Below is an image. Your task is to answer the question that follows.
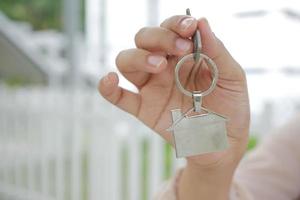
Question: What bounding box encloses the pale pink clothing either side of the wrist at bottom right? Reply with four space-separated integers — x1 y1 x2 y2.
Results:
155 116 300 200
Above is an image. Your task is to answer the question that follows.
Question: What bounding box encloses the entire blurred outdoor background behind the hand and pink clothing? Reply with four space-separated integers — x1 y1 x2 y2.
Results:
0 0 300 200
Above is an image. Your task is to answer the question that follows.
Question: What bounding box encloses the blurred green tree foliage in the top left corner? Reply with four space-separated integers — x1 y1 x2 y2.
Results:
0 0 84 30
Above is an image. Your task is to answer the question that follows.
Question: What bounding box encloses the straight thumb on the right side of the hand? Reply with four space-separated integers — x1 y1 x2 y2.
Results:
198 18 245 80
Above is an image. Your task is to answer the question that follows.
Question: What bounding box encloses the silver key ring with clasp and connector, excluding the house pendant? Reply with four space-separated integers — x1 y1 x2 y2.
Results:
175 9 218 112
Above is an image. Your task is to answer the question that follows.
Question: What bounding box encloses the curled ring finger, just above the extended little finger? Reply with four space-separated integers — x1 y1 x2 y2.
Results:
116 49 167 88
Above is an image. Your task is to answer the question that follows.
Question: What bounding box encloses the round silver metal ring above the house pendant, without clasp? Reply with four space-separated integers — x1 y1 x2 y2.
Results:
175 53 218 97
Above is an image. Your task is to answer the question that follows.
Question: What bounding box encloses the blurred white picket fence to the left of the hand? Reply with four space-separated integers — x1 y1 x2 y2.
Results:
0 87 184 200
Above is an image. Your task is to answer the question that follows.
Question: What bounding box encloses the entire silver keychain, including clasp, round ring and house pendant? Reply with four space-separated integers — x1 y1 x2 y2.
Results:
167 9 228 158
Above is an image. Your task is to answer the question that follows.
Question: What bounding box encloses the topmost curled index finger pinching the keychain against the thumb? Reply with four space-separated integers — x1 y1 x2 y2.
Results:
160 15 197 38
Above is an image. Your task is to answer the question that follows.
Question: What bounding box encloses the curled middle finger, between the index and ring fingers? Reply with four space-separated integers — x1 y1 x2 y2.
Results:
135 27 193 56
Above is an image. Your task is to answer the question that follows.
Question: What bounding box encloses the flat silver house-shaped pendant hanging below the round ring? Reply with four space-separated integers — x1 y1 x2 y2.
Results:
168 109 228 158
